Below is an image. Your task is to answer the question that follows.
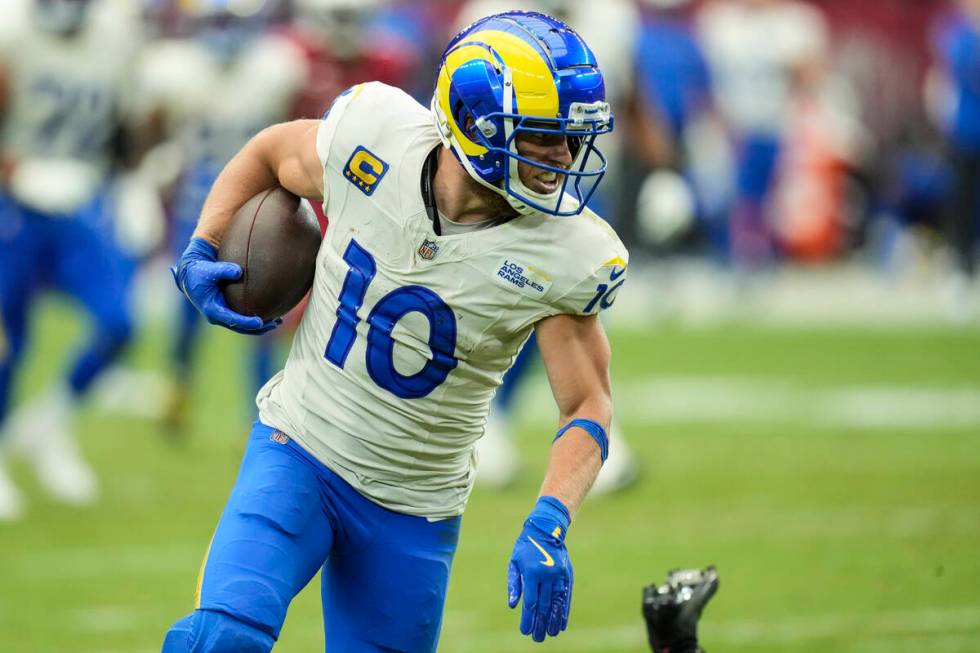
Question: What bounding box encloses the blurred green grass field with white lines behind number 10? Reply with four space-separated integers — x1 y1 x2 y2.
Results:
0 304 980 653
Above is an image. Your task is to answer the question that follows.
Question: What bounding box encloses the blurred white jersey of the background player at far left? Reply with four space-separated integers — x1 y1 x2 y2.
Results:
0 0 141 214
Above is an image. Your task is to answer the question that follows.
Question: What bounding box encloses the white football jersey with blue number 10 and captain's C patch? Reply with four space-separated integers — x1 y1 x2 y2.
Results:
258 82 627 518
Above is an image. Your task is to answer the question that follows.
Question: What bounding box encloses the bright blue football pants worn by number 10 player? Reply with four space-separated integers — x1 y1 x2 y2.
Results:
163 422 460 653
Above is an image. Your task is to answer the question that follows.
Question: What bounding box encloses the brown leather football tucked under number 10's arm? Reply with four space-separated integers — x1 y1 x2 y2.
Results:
218 187 321 320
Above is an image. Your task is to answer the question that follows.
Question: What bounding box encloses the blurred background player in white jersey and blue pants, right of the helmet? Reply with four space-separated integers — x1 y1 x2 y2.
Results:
699 0 827 272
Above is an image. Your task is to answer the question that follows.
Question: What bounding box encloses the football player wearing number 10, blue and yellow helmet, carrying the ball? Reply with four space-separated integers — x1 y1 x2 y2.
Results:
163 12 628 653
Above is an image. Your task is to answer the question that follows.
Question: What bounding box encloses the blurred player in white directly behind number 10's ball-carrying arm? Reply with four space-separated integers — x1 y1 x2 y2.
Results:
143 0 308 429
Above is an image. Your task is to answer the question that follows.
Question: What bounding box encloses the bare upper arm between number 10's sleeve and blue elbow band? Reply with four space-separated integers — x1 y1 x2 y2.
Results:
534 315 610 415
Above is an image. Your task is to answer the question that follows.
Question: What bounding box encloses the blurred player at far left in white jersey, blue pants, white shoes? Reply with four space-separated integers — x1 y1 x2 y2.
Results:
0 0 147 518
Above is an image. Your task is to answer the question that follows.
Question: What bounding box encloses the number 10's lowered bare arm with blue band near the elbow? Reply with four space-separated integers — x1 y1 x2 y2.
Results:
535 315 612 516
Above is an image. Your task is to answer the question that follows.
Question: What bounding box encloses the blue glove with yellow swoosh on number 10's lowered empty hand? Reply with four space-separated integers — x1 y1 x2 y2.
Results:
507 496 574 642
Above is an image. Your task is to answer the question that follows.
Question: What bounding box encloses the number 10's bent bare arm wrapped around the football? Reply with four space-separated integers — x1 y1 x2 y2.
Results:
194 120 323 246
